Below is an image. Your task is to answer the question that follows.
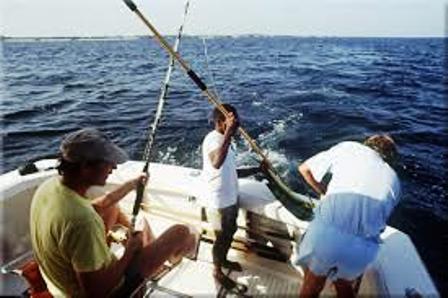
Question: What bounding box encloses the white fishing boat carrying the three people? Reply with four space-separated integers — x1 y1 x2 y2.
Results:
0 159 439 297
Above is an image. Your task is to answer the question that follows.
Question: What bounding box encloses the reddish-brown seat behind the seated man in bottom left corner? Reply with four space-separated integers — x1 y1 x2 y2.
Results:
1 252 53 298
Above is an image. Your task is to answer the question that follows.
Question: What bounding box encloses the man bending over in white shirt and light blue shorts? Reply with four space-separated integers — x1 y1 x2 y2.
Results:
295 135 400 297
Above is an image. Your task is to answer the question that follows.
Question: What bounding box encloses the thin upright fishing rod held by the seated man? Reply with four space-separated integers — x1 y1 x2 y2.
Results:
131 0 190 230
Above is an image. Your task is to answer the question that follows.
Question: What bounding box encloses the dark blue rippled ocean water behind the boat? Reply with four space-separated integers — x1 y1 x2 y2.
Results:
0 36 448 293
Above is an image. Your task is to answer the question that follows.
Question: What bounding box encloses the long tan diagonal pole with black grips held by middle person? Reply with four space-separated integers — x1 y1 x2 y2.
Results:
123 0 314 219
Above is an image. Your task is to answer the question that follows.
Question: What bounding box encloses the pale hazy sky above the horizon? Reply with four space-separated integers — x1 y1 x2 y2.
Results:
0 0 448 37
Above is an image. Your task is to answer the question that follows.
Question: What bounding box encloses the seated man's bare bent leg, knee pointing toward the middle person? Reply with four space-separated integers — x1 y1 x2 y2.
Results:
136 225 196 277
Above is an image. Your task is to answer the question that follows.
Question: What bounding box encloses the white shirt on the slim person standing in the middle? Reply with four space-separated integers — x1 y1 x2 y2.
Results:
202 130 238 209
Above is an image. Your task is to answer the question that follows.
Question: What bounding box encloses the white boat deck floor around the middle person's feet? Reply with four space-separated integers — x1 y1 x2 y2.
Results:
128 193 334 297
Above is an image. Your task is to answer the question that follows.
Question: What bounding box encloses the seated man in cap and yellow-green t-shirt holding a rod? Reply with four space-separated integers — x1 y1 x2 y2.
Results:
30 129 195 297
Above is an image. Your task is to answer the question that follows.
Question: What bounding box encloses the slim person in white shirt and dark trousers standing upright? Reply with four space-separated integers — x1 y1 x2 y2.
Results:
202 104 260 289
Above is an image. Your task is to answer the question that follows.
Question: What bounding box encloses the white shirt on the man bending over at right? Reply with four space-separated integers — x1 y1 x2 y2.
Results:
305 142 400 238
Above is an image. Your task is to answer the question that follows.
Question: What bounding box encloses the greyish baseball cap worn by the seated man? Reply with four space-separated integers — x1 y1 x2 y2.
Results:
59 128 128 164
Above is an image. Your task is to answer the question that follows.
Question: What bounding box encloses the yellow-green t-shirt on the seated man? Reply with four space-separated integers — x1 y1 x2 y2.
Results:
30 177 115 297
